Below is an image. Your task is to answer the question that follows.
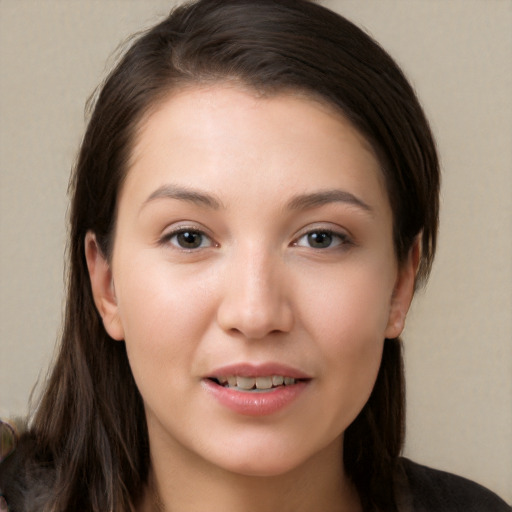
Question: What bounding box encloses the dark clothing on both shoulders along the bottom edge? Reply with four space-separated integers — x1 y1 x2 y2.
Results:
0 436 512 512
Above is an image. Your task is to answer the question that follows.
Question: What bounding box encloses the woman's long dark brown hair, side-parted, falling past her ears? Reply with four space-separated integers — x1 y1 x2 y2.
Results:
25 0 439 512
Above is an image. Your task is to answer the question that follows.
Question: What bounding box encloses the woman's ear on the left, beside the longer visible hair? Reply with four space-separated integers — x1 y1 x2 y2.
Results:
85 231 124 340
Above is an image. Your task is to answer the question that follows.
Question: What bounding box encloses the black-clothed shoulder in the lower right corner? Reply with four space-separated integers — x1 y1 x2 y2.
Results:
401 459 512 512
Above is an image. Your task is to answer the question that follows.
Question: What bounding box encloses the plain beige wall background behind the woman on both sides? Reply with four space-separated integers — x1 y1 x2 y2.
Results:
0 0 512 501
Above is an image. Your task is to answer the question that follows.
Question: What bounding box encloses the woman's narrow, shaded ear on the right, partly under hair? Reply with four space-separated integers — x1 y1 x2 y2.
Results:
385 236 421 339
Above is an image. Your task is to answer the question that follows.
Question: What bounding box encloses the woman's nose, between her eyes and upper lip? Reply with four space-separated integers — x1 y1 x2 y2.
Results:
217 245 293 340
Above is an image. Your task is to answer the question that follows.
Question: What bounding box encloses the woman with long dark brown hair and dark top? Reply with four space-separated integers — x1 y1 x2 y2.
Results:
0 0 507 511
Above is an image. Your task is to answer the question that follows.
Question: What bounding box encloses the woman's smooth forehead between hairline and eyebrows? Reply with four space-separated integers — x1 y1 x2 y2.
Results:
125 84 384 211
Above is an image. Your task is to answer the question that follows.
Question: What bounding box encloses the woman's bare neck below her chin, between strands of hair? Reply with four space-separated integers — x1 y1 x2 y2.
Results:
140 439 362 512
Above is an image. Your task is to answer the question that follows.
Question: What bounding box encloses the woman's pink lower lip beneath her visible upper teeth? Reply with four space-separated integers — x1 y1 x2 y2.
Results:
203 379 309 416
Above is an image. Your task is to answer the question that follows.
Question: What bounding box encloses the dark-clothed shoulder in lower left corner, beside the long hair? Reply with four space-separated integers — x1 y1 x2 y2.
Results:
0 433 55 512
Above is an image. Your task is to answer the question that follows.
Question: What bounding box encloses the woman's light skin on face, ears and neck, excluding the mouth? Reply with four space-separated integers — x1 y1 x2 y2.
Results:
86 84 418 512
